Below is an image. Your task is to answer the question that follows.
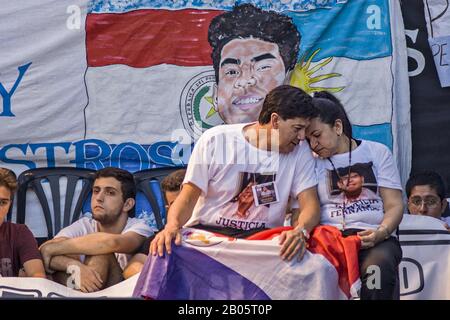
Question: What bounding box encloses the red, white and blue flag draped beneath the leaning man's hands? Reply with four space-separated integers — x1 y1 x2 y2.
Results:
134 226 360 300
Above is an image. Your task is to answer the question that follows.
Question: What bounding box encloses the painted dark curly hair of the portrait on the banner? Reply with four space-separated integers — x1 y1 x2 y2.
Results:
208 3 301 83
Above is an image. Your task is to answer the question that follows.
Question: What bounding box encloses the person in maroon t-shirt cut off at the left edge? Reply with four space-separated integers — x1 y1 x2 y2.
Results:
0 168 45 278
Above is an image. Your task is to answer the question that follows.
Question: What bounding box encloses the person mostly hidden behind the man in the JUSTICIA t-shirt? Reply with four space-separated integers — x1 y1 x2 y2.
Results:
123 169 186 279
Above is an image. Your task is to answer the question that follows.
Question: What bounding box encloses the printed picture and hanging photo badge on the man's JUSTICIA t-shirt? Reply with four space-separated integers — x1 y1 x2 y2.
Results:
220 172 278 227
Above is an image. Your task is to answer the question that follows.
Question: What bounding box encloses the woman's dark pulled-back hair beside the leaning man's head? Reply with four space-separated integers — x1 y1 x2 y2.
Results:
313 91 353 140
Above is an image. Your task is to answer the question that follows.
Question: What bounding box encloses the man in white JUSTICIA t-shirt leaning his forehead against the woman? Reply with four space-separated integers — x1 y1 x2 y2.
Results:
150 85 320 260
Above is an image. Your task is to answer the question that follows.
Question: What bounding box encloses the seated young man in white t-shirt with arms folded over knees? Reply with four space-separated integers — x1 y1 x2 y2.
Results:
41 168 152 292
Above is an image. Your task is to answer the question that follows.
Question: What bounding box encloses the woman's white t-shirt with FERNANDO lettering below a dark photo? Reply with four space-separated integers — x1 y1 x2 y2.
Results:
316 140 402 230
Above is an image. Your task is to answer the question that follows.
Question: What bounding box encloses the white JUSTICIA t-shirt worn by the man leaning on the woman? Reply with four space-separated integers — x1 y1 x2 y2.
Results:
183 124 317 230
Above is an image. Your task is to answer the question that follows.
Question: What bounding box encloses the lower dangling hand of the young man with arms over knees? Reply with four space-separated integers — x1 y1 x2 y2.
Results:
67 263 103 293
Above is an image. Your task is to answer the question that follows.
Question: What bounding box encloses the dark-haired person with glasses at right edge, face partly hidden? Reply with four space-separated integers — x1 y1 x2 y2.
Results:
406 171 450 231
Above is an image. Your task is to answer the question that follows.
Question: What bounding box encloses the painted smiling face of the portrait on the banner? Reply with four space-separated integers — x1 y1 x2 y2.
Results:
216 38 286 124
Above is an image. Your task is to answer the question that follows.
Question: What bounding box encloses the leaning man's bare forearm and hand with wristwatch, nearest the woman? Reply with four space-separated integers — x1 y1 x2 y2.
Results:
280 187 320 261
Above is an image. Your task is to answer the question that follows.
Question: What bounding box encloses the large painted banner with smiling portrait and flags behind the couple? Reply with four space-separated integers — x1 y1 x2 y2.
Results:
0 0 411 185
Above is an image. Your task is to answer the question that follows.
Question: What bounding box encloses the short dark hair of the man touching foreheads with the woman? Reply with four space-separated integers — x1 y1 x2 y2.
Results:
258 85 317 124
